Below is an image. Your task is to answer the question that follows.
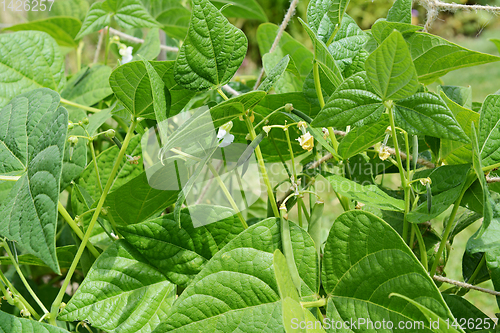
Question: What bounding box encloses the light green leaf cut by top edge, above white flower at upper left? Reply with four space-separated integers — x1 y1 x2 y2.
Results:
76 0 158 39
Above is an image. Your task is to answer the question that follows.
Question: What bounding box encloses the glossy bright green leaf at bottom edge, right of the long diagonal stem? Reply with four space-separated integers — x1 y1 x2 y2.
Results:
58 240 176 333
